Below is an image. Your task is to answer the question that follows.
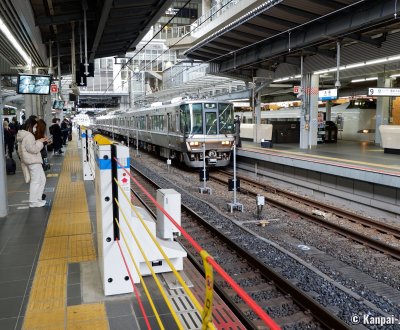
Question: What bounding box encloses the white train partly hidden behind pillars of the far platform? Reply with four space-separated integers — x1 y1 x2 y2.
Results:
235 99 376 143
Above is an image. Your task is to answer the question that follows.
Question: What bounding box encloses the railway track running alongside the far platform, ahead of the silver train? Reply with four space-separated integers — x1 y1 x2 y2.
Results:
210 170 400 260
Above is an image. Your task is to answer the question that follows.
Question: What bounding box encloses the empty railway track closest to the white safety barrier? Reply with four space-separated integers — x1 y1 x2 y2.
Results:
132 168 348 329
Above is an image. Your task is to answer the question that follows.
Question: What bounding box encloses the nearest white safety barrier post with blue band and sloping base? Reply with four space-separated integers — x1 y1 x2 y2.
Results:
94 138 186 295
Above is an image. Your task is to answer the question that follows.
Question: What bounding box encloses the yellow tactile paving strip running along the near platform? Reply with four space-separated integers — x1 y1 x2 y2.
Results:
23 141 109 330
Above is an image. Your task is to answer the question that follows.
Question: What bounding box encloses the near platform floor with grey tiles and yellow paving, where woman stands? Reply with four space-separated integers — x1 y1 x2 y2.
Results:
0 140 244 330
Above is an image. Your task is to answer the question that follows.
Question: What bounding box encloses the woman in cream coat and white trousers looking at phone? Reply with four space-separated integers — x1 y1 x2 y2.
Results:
17 119 47 207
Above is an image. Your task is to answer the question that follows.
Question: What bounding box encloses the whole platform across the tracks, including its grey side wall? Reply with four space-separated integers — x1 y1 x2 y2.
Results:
237 140 400 216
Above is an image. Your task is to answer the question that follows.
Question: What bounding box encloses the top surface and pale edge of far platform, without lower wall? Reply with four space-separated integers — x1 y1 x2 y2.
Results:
237 140 400 189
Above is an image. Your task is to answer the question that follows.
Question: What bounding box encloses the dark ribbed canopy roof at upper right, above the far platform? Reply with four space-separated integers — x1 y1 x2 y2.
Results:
186 0 400 73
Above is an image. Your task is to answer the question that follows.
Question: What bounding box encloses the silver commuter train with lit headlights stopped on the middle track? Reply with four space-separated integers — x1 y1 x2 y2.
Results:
94 100 235 168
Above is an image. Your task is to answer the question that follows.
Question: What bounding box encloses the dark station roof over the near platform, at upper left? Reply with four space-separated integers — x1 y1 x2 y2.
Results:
0 0 172 73
